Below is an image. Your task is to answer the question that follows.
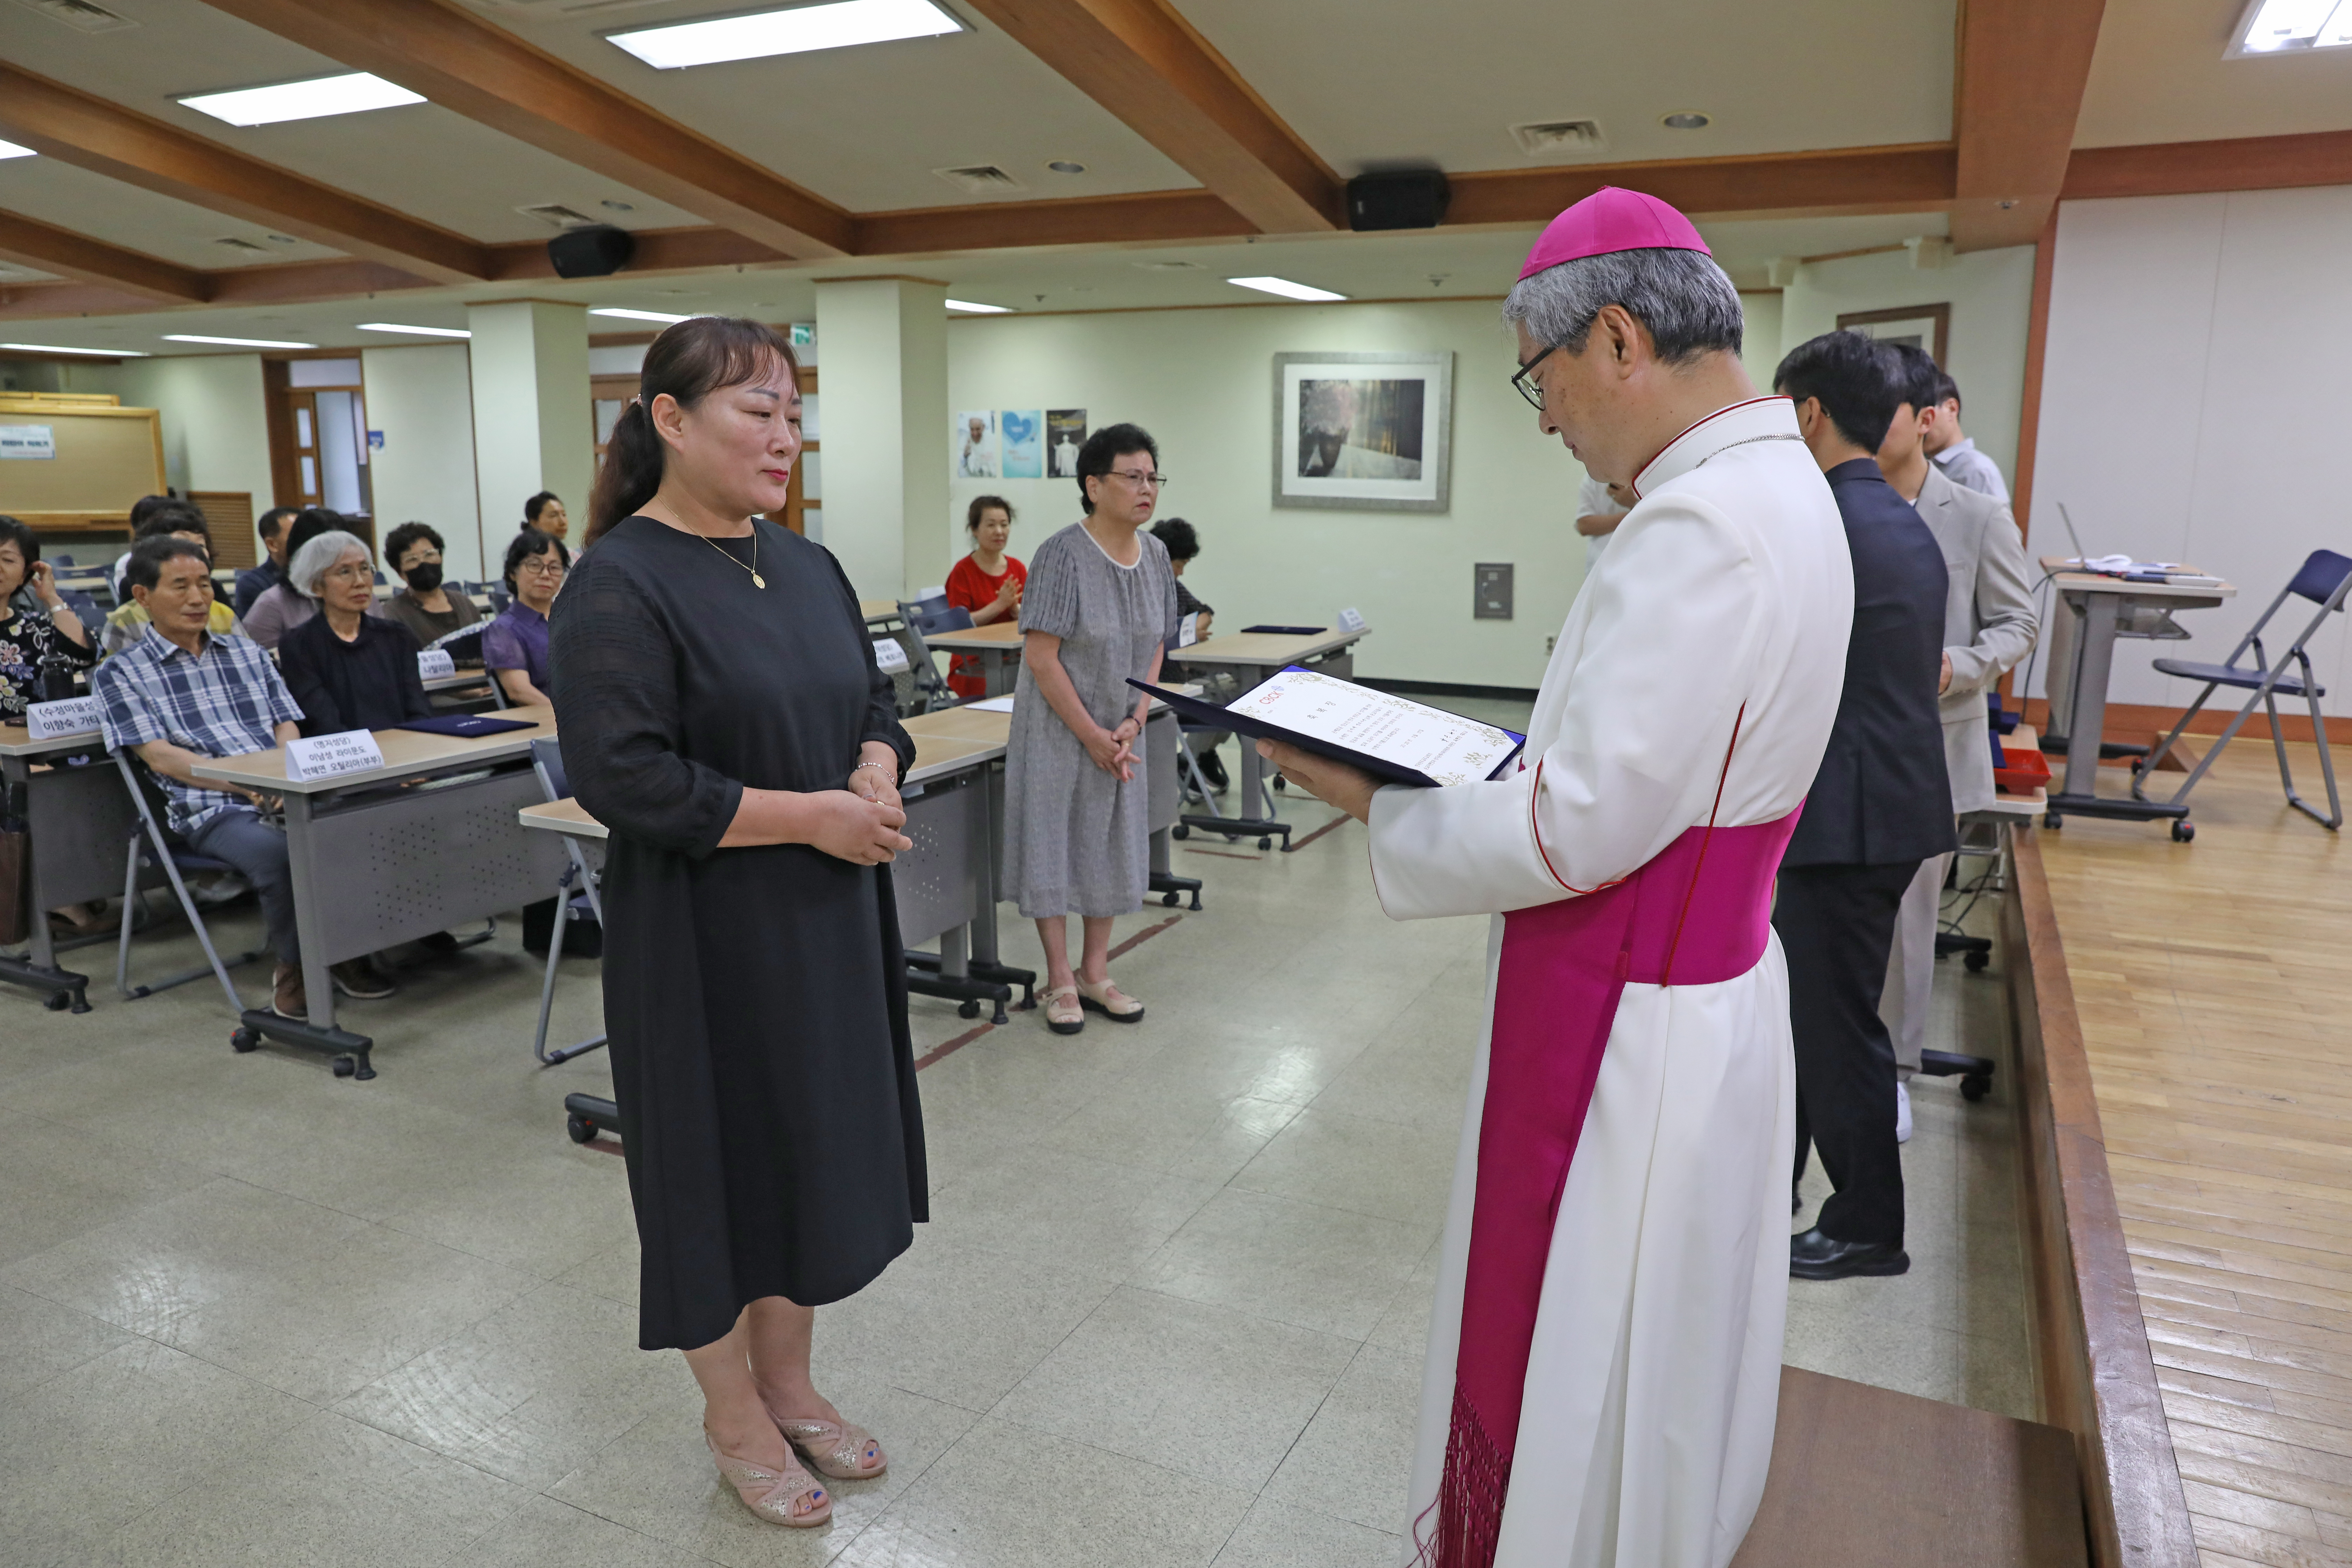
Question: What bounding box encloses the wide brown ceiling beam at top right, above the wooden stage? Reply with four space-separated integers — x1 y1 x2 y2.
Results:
1952 0 2105 252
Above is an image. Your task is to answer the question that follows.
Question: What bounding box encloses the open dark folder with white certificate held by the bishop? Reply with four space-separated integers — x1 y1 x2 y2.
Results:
1127 665 1526 788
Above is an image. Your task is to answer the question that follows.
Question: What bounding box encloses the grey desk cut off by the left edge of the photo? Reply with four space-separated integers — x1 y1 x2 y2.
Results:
0 724 139 1013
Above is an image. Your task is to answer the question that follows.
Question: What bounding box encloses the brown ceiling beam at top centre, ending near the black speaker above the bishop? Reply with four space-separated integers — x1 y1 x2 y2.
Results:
945 0 1348 233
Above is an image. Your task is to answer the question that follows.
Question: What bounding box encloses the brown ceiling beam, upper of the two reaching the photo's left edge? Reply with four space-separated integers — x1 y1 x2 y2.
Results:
0 61 489 282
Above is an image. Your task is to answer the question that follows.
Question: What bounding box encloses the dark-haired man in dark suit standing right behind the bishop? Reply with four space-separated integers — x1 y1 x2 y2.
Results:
1773 331 1954 1279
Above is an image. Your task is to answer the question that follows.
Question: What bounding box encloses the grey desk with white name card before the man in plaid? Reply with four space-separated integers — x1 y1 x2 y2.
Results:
193 708 565 1079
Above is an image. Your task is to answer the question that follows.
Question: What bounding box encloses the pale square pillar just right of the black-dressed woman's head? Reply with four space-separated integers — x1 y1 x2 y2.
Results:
816 278 950 600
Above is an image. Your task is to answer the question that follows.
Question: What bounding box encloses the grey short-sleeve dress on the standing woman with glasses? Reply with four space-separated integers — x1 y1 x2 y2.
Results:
1004 524 1176 919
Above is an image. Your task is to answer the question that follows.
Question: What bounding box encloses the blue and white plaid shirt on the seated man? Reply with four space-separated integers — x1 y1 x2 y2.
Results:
89 625 301 834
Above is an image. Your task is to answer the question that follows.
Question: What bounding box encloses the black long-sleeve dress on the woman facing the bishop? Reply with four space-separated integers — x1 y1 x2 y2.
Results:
550 517 929 1349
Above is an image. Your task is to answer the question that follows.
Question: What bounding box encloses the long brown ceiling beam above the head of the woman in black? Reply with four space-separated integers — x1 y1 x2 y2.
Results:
209 0 854 261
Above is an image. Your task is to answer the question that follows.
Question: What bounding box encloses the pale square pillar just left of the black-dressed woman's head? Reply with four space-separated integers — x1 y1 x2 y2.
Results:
466 299 595 576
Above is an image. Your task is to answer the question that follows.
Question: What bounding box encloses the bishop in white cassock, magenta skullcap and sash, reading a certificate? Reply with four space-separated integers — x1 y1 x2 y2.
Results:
1261 190 1853 1568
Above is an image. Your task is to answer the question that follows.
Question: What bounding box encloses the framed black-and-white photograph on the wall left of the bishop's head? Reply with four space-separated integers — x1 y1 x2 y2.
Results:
1275 350 1454 512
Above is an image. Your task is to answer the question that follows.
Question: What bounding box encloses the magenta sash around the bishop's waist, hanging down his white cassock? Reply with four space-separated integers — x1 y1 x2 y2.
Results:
1416 799 1804 1568
